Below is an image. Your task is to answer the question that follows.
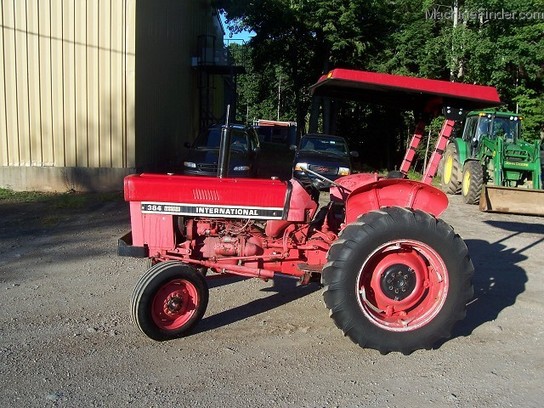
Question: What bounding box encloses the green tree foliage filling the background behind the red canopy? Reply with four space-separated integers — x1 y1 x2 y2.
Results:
218 0 544 168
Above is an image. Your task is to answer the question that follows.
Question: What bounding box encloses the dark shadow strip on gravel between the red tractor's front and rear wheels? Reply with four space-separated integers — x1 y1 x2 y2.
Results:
192 278 321 334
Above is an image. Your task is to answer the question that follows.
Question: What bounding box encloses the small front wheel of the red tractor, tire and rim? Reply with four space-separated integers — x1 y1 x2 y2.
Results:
131 261 209 341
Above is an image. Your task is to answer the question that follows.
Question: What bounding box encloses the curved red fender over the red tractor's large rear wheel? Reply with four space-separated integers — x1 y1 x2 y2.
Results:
346 179 448 224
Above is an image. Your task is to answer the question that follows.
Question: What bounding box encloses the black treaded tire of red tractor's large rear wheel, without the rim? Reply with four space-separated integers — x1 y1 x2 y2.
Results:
324 208 471 353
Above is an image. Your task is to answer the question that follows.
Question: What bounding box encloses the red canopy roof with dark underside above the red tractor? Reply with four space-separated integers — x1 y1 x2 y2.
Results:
310 68 501 113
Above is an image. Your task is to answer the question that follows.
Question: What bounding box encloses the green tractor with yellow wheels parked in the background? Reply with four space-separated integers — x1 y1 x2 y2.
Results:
441 110 542 213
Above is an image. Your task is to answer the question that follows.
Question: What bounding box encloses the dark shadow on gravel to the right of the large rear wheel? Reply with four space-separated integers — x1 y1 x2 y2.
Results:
452 221 544 337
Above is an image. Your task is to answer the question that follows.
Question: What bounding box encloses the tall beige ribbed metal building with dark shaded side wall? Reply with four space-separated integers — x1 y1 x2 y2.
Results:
0 0 239 191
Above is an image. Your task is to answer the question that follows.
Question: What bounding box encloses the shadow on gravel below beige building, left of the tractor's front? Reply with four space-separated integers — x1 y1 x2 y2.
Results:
0 193 130 282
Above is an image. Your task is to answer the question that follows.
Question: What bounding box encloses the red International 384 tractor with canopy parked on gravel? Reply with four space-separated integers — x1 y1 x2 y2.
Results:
119 70 498 354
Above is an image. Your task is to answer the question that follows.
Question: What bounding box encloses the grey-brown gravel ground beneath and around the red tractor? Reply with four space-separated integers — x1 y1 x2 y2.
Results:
0 192 544 407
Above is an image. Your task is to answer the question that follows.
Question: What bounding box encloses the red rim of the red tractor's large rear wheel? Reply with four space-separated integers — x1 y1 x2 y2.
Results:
357 240 449 332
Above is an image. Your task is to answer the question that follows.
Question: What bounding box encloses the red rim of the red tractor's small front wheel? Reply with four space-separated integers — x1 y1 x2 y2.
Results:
151 279 199 330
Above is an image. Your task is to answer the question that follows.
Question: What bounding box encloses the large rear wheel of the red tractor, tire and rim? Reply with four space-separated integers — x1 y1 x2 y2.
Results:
321 207 474 354
